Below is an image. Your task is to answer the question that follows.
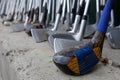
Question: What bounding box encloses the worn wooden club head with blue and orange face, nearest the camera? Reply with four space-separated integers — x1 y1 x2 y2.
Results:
53 46 99 75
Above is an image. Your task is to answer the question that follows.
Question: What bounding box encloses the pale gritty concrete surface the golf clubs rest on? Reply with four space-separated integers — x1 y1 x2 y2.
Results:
0 24 120 80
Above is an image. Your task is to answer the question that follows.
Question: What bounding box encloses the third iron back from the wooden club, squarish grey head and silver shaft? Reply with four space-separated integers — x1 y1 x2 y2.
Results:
31 0 63 43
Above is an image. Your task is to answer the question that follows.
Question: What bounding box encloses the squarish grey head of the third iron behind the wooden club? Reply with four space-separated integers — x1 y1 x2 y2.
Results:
31 29 48 43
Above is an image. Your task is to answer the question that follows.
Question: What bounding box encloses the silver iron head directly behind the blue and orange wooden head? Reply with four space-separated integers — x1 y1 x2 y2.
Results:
54 38 85 53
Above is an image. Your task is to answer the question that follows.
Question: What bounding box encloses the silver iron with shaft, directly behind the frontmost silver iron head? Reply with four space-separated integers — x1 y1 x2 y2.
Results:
48 0 84 47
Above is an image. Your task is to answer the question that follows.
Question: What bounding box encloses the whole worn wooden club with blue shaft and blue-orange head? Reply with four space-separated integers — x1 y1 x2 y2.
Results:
53 0 114 75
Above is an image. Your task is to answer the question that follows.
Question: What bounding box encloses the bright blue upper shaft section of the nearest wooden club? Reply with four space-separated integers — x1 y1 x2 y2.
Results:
97 0 114 33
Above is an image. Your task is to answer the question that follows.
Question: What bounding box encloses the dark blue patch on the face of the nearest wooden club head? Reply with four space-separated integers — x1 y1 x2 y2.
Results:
75 46 99 74
